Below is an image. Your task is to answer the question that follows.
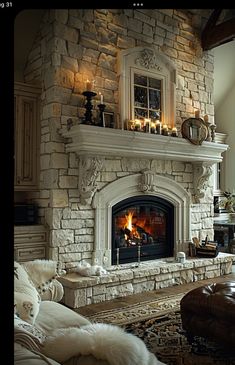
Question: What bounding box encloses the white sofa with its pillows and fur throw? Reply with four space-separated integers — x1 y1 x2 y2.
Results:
14 260 164 365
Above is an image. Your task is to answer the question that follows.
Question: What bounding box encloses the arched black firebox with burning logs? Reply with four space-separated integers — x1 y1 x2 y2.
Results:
112 195 174 265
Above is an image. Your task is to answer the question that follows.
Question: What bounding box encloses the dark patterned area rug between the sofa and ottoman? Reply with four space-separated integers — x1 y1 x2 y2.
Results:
89 294 235 365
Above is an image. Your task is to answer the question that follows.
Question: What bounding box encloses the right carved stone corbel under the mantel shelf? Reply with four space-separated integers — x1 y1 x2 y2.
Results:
193 162 213 203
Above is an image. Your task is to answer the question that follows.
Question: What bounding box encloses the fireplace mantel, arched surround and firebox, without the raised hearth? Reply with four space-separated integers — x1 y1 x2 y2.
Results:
61 124 227 267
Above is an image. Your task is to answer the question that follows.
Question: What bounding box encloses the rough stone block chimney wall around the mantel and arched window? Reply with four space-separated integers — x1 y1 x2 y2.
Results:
25 9 214 266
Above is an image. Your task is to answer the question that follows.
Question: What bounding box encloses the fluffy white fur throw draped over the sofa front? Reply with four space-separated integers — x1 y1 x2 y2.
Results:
42 323 164 365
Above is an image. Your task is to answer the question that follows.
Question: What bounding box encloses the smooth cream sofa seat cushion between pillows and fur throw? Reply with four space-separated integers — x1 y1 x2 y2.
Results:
35 300 90 334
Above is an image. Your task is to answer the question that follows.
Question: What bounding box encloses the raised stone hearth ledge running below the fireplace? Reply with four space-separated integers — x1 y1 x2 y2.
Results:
59 253 235 308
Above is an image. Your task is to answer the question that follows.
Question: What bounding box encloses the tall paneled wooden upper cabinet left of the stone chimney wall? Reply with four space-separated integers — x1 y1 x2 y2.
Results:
14 82 41 191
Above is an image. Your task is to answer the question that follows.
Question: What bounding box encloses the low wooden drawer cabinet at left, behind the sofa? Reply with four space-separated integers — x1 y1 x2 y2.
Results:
14 225 48 262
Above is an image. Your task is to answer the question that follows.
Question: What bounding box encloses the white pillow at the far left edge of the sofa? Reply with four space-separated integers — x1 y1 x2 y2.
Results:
14 261 41 324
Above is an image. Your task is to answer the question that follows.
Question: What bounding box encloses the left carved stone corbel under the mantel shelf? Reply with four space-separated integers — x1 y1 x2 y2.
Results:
78 156 103 205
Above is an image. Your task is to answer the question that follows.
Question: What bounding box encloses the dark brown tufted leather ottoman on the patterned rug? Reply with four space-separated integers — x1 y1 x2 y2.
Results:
180 281 235 349
